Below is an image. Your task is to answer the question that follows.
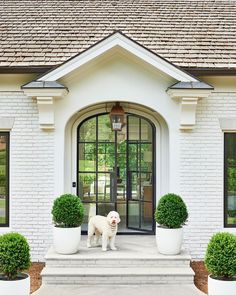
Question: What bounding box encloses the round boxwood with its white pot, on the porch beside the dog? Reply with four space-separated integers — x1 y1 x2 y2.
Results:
52 194 84 254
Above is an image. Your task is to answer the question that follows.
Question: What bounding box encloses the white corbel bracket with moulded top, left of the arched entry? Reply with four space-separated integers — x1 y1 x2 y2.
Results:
23 88 68 130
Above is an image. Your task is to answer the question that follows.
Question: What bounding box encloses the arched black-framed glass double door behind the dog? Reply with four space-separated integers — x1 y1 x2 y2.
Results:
77 114 155 233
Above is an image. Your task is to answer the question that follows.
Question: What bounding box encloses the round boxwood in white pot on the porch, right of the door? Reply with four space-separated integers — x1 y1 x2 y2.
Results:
155 194 188 255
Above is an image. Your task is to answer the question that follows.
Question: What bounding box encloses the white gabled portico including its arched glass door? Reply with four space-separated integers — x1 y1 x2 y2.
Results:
22 32 212 238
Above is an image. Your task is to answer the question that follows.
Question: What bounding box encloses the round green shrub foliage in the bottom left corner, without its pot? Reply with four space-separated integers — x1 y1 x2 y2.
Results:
0 233 31 280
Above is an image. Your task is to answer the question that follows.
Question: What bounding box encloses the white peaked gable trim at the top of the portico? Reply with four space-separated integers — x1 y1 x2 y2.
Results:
37 31 198 82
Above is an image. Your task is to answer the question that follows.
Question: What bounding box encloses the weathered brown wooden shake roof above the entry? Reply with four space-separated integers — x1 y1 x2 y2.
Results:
0 0 236 70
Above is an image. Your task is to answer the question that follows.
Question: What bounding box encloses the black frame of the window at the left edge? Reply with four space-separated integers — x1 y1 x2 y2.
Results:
0 131 10 228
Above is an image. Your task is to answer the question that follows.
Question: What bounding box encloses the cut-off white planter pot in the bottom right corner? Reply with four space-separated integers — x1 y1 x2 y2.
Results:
208 276 236 295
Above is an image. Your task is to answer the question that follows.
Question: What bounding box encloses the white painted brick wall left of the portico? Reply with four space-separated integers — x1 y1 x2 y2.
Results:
0 91 54 261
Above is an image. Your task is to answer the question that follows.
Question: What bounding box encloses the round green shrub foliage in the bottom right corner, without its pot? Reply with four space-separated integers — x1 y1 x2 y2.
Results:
205 233 236 278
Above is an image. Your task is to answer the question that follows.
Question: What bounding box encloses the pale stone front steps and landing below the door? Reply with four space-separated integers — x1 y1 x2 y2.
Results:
41 235 194 286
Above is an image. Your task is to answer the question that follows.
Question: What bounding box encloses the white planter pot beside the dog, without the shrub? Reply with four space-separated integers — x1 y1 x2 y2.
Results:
53 227 81 254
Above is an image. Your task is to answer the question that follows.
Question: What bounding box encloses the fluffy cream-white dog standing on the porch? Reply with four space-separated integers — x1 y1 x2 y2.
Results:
87 211 120 251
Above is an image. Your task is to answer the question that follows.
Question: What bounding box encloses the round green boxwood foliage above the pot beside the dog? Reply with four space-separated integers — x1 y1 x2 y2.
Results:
52 194 84 227
